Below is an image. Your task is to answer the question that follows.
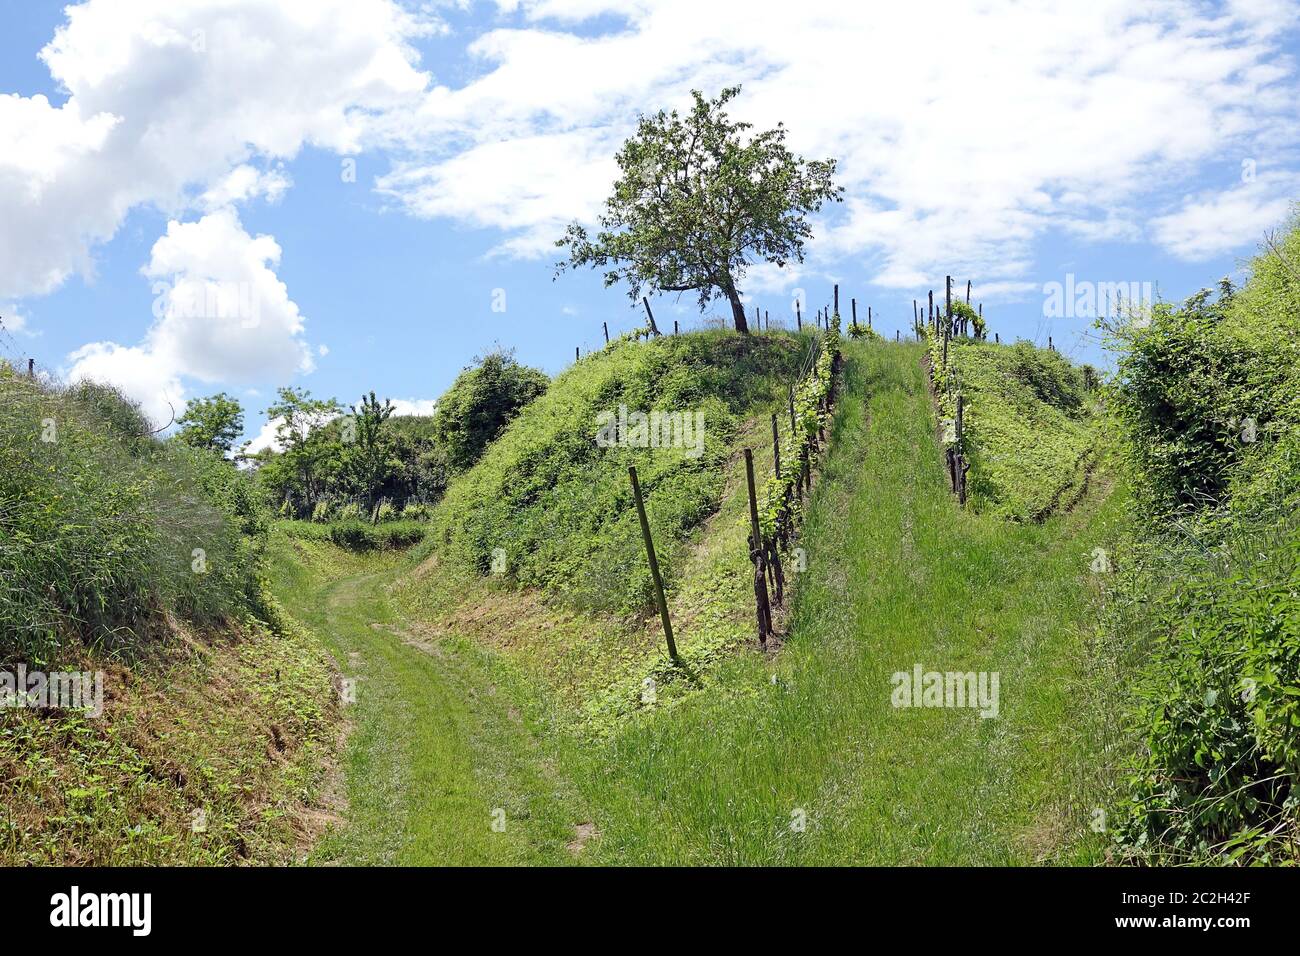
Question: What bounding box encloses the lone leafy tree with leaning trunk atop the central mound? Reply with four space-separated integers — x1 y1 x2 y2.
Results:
555 86 844 332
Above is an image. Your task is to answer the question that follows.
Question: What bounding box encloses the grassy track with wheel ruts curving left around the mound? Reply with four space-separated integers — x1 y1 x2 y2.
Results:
272 531 586 865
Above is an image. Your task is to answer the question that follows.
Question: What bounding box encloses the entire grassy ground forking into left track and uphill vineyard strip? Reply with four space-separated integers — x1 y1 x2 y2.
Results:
276 343 1117 864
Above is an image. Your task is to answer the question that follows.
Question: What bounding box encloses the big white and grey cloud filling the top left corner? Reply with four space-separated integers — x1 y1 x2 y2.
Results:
0 0 433 297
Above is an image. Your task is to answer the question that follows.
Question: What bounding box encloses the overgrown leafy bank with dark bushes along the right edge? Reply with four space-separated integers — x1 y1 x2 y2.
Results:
1108 210 1300 864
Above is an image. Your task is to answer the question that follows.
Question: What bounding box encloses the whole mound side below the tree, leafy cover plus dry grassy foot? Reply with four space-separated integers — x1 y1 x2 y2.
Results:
395 330 814 721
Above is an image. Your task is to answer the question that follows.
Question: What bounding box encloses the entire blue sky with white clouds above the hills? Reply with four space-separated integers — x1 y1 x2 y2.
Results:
0 0 1300 450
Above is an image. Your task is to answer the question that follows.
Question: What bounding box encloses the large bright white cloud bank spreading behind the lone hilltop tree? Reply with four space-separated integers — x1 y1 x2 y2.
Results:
380 0 1300 289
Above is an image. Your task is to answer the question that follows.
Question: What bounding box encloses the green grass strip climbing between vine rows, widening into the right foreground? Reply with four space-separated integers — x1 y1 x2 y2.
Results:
559 345 1114 864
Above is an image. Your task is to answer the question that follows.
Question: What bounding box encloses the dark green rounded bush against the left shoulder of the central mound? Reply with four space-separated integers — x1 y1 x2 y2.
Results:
433 350 550 470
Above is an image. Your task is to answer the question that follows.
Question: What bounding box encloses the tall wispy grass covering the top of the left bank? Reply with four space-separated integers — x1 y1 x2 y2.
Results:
0 365 264 662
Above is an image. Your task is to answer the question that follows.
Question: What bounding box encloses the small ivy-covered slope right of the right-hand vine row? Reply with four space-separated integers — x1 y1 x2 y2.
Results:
930 334 1097 522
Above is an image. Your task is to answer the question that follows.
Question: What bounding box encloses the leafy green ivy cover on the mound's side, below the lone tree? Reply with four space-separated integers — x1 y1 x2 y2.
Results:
429 332 810 613
